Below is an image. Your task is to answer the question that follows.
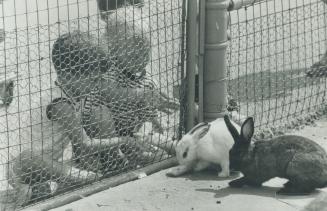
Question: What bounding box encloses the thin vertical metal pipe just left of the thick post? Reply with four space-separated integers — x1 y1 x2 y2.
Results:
185 0 198 131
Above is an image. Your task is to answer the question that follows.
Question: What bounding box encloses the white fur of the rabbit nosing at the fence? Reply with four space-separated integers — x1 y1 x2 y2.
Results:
167 118 240 177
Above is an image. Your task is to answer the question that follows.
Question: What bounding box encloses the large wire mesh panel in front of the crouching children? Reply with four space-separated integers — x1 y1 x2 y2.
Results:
0 0 183 210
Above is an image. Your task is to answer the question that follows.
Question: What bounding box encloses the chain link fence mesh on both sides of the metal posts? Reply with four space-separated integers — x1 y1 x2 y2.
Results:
0 0 327 210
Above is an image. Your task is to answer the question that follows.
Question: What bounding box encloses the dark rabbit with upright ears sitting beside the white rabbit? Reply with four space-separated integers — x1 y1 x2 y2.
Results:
224 115 327 195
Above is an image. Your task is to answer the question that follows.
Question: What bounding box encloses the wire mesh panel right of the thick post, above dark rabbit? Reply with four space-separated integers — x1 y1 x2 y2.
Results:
227 0 327 132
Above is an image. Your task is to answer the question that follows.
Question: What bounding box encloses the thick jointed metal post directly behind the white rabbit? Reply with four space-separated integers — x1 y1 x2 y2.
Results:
203 0 230 121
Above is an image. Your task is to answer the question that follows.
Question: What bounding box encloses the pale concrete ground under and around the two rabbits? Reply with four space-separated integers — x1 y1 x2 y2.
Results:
32 118 327 211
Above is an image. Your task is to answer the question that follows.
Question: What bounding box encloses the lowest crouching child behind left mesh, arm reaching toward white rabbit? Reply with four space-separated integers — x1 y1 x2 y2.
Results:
8 91 176 206
